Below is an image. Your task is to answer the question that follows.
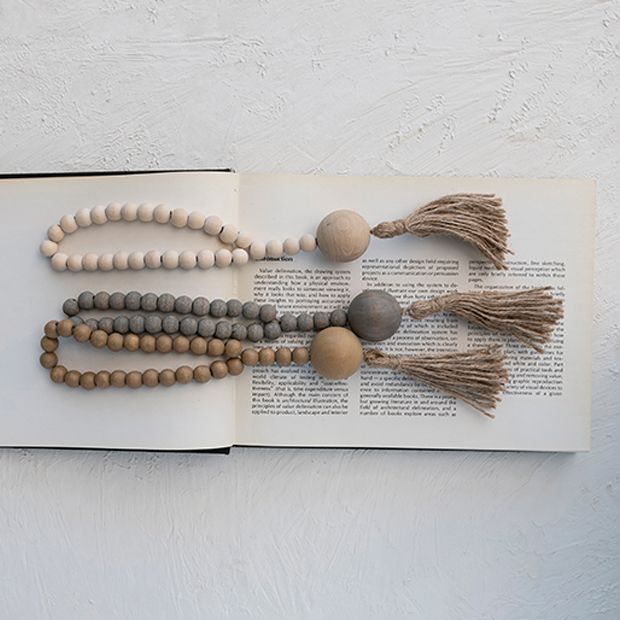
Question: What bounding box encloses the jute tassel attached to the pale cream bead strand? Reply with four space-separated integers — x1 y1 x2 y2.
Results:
370 194 510 269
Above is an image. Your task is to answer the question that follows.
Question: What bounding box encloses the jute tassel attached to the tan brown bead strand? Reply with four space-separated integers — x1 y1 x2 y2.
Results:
364 345 508 418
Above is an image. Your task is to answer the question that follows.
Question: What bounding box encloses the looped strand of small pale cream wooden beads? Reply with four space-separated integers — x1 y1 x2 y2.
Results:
39 202 317 272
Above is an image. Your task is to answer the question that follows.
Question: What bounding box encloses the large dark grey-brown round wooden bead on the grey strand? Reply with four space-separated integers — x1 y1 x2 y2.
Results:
349 291 402 342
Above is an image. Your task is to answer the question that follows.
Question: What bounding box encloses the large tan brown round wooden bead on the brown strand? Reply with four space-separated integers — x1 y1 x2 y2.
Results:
310 327 364 379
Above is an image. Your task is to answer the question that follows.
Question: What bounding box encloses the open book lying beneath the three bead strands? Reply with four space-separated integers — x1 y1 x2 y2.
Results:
0 172 595 451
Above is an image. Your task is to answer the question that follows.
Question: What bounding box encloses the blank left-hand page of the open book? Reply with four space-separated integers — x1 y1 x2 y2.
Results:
0 172 238 450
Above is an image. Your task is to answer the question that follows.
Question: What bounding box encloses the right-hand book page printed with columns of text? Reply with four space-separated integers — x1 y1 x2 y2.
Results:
236 175 595 451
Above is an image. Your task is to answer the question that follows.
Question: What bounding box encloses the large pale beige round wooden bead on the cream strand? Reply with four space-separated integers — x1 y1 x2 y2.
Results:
316 209 370 263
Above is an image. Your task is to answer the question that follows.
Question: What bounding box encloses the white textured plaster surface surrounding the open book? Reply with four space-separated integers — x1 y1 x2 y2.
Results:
0 0 620 620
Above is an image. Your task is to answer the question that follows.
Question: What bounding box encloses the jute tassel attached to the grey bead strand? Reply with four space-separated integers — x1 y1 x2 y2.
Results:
404 286 564 353
